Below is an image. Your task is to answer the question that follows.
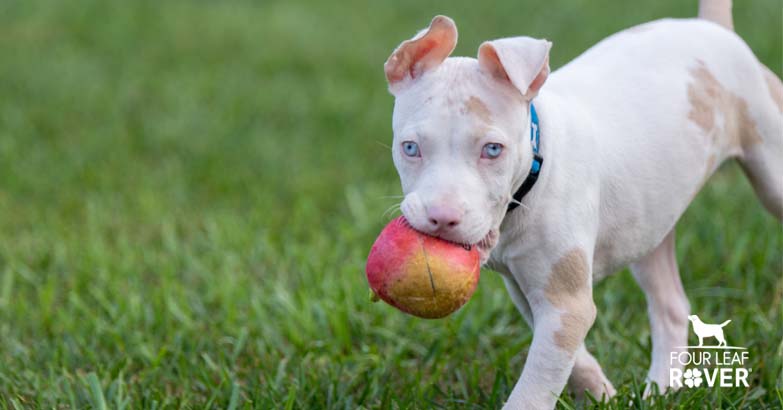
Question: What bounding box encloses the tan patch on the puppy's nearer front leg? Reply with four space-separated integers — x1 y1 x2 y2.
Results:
545 249 595 353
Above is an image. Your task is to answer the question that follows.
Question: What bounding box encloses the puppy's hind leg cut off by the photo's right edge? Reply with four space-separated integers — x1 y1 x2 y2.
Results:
738 64 783 220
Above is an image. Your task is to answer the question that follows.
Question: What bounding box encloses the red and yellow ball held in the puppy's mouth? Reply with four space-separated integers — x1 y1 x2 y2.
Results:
366 216 481 319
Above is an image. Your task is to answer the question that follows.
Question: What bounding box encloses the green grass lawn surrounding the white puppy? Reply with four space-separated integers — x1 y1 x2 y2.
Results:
0 0 783 409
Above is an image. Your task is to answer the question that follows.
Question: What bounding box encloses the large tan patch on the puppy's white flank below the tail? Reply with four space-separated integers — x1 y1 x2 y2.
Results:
688 60 761 150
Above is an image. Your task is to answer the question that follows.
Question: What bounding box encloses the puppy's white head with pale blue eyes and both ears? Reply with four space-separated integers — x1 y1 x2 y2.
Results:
384 16 551 262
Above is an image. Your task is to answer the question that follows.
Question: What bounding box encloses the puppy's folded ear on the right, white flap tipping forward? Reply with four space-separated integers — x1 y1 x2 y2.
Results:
478 37 552 100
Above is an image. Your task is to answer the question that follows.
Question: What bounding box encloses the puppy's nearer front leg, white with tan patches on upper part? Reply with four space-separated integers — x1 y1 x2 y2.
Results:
505 247 596 409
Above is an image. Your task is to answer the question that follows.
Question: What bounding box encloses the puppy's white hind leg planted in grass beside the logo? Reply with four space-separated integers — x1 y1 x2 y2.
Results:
631 229 690 394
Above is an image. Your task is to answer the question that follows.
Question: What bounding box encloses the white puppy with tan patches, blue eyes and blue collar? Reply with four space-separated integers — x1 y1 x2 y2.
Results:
384 0 783 409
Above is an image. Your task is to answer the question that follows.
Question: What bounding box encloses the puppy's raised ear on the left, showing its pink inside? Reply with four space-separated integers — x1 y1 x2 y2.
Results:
383 16 457 94
